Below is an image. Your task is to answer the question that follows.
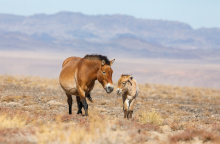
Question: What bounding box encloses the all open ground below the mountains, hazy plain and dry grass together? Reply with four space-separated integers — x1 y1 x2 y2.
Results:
0 52 220 144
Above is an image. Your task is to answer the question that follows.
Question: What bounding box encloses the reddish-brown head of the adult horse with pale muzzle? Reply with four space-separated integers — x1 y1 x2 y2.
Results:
97 59 115 93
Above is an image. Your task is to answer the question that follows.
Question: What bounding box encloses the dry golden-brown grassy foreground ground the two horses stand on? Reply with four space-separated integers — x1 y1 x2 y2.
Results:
0 75 220 144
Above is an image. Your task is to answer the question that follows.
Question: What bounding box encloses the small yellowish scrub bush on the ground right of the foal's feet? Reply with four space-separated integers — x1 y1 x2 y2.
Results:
138 109 163 126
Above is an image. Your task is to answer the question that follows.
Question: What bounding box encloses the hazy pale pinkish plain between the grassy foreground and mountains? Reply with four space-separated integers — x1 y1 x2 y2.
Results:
0 51 220 89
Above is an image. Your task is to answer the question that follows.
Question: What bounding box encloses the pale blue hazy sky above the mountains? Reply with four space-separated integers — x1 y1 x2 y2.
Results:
0 0 220 28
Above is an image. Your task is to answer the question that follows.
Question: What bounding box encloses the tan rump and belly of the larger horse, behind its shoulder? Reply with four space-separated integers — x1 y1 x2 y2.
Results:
59 57 81 94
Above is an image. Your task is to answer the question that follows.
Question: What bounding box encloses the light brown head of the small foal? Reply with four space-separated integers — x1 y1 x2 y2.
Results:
117 74 133 95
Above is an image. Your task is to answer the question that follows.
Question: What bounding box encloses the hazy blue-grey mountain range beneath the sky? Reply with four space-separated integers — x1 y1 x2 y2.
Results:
0 12 220 61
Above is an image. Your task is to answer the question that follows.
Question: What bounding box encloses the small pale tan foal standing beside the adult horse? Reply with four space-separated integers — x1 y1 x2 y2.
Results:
117 74 139 119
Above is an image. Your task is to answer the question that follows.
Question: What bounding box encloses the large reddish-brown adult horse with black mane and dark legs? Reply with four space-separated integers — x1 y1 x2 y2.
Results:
59 55 115 116
